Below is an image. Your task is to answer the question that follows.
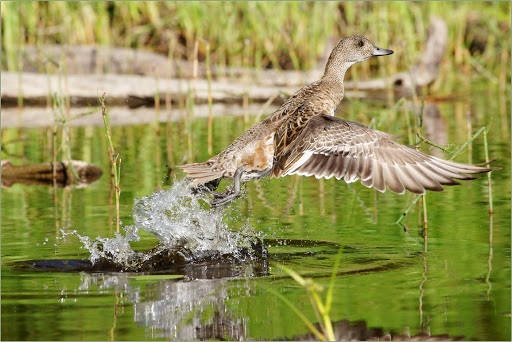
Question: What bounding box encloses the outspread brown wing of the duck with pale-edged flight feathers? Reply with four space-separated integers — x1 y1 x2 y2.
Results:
273 115 491 194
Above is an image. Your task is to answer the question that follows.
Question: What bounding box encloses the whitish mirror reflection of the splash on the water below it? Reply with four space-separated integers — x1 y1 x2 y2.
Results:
80 273 249 340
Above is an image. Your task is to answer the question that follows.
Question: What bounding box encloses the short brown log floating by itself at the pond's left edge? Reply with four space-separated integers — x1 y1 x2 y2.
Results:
1 160 103 187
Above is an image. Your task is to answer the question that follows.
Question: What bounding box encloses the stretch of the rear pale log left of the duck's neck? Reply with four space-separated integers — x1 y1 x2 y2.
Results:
20 45 321 86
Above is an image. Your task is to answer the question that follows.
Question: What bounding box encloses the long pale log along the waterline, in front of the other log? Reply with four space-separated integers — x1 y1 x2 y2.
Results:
1 72 367 107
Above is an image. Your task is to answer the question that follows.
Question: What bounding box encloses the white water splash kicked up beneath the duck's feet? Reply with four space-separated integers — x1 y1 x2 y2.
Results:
62 180 258 269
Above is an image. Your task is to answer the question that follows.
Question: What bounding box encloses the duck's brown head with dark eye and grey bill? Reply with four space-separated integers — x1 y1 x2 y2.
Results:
324 34 393 80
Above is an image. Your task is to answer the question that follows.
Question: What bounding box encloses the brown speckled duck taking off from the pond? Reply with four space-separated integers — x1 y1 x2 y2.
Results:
180 35 491 207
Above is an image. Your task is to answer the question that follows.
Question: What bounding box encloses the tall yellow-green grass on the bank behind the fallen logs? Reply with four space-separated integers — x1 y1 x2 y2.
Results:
1 1 510 82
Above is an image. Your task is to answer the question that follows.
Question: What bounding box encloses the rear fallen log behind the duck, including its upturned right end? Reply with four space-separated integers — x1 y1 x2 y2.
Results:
16 17 447 89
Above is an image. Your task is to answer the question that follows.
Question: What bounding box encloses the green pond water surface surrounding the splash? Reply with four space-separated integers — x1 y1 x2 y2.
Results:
1 96 511 340
